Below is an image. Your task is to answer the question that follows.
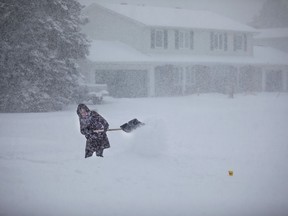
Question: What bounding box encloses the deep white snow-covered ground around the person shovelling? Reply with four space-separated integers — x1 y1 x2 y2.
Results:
0 93 288 216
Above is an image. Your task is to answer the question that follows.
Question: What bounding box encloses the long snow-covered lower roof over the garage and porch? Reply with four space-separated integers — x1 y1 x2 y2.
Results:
88 40 288 65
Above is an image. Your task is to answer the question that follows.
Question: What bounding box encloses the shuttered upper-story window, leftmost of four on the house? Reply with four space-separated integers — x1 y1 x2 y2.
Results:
151 29 168 49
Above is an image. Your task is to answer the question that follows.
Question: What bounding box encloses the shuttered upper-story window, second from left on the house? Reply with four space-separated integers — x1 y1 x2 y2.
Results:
175 30 194 49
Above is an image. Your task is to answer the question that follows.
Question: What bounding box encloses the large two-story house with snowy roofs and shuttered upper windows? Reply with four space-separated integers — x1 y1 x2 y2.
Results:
81 4 288 97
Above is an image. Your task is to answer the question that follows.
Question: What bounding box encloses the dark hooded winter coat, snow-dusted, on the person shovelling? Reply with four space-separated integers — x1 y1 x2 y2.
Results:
77 104 110 158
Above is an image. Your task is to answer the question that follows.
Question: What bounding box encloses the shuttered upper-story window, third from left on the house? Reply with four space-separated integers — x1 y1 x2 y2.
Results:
210 32 228 51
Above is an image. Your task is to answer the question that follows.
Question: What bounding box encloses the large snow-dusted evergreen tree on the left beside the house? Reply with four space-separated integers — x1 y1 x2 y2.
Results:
0 0 88 112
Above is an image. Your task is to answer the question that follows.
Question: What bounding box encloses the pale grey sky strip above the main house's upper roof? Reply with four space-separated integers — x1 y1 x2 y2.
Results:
78 0 265 23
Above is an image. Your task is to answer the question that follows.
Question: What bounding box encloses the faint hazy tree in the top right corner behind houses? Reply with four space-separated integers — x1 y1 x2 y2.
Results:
250 0 288 28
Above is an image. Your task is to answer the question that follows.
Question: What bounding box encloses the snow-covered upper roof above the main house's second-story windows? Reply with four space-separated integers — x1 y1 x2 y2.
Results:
90 3 256 32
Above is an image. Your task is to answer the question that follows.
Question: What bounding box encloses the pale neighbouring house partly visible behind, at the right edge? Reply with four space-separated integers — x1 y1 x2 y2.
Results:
254 28 288 53
